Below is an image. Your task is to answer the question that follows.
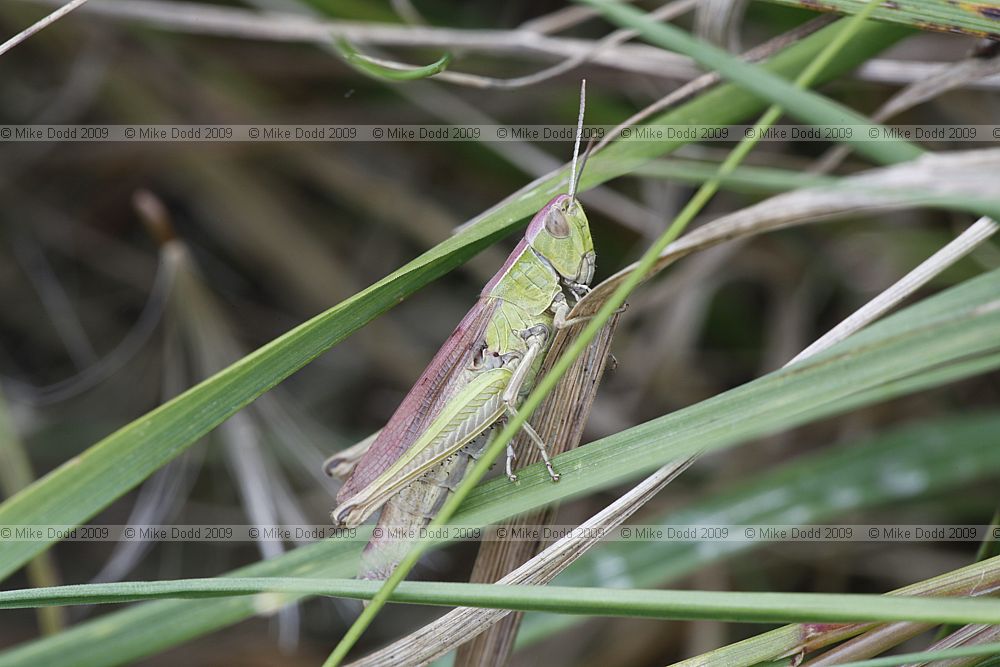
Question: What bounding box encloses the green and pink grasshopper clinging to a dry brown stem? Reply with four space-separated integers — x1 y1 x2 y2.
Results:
325 83 596 578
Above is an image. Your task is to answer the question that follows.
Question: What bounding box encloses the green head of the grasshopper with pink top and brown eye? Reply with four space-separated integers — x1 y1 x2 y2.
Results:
525 195 595 285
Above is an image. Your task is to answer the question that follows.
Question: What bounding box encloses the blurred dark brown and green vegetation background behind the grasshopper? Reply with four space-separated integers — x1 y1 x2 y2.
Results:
0 0 1000 665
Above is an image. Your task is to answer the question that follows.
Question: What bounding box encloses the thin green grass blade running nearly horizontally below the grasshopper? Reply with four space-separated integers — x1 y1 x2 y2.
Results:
0 576 1000 624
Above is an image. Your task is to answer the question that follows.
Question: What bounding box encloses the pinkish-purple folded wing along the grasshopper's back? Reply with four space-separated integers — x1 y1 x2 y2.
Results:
337 297 496 502
